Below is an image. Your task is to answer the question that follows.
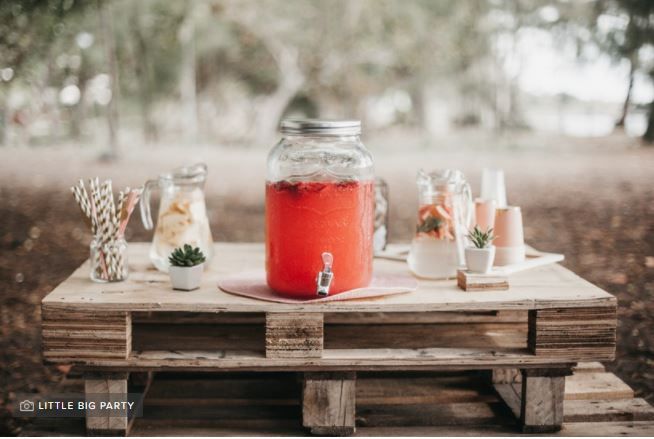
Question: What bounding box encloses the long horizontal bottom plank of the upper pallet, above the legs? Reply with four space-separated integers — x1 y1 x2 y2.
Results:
57 348 576 372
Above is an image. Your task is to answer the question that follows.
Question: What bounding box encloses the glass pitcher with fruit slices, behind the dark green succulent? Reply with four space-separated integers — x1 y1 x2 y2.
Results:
141 163 213 271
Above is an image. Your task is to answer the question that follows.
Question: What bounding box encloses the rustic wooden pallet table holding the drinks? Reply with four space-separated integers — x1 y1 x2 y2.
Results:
42 244 616 434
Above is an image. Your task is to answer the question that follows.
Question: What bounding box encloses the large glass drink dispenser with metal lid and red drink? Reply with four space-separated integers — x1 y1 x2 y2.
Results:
266 120 375 298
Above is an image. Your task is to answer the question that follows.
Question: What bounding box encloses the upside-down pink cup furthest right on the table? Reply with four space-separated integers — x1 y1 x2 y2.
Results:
493 206 525 265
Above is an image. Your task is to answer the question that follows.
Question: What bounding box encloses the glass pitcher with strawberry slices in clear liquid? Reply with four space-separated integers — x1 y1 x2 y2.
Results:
408 169 473 279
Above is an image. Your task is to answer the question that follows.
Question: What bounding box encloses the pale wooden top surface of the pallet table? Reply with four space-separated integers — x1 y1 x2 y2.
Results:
43 243 616 313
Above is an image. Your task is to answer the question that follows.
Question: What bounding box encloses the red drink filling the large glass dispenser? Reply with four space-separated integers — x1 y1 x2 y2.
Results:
266 181 375 298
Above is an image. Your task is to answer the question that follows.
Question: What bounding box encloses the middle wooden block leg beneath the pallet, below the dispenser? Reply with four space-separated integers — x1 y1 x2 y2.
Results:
302 372 356 436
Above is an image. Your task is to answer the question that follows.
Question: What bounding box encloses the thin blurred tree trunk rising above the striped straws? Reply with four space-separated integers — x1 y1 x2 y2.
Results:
98 0 120 158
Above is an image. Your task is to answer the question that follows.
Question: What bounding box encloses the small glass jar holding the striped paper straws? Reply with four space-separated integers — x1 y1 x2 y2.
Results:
89 237 129 282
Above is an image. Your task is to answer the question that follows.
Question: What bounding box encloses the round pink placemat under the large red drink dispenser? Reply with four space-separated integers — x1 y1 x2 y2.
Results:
218 270 418 303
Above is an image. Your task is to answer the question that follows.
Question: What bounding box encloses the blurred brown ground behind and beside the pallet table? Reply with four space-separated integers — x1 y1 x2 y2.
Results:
0 135 654 435
